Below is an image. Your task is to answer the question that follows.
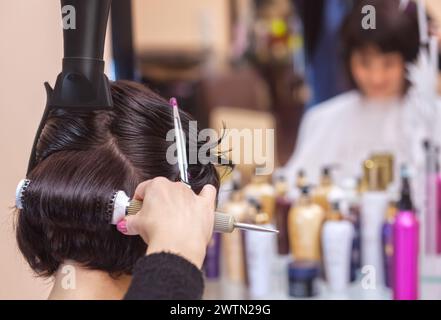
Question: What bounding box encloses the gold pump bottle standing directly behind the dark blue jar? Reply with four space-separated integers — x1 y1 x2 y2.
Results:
288 186 325 262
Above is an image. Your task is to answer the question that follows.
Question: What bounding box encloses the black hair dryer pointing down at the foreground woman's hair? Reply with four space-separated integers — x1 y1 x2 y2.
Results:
48 0 112 111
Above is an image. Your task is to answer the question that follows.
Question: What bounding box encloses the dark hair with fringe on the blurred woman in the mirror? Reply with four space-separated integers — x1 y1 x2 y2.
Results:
341 0 420 88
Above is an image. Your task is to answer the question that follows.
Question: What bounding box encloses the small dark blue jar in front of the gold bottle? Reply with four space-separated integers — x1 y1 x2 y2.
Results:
288 261 320 298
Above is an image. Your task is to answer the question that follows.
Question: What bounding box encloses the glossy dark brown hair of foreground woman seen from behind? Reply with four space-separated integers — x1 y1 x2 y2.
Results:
17 81 223 276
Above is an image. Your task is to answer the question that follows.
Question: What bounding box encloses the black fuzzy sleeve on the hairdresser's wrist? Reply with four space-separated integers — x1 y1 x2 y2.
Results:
124 252 204 300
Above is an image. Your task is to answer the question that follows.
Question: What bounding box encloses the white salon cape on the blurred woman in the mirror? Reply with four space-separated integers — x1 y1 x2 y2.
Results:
283 90 441 201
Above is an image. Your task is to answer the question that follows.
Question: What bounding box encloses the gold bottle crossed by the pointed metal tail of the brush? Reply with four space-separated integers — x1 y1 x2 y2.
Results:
221 185 249 284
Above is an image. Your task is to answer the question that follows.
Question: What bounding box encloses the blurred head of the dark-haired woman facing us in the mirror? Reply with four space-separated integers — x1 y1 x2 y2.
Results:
342 0 419 99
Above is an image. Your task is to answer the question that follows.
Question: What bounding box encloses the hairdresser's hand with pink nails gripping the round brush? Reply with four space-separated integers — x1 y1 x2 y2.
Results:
118 177 216 268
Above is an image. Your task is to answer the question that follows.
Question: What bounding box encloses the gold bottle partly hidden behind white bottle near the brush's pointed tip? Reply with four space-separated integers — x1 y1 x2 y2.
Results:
243 175 276 221
